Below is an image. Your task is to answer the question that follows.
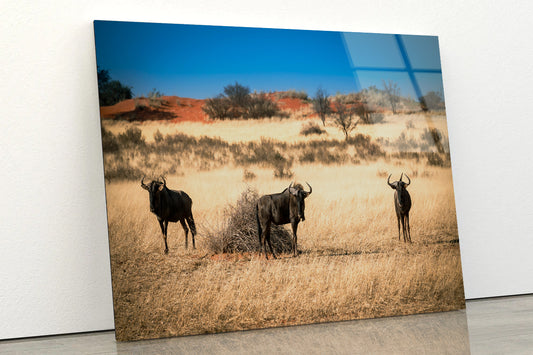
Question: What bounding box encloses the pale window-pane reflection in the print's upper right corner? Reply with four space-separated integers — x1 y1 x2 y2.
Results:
341 33 449 153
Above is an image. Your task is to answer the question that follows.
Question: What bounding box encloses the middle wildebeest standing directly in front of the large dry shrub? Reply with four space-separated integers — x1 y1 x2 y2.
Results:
256 182 313 260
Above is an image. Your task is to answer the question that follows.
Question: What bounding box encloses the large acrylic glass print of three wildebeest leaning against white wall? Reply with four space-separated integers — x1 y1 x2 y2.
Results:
94 21 465 340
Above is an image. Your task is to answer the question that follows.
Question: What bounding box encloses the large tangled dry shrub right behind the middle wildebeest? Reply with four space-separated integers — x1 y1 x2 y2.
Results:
207 187 292 253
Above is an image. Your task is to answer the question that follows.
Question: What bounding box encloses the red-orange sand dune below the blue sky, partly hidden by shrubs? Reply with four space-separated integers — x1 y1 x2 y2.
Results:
100 95 309 122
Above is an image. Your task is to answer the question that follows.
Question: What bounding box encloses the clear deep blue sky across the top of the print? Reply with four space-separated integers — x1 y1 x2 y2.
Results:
94 21 443 98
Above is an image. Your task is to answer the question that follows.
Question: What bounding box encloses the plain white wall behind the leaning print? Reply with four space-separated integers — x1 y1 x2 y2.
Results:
0 0 533 338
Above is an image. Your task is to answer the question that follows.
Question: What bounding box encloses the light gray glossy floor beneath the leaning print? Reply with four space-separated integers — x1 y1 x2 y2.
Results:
0 295 533 354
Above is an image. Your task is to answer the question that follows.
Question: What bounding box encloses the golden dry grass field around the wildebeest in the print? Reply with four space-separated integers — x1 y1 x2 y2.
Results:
104 115 464 340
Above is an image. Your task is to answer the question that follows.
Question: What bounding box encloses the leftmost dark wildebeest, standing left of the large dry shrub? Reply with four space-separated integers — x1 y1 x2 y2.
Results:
141 176 196 254
